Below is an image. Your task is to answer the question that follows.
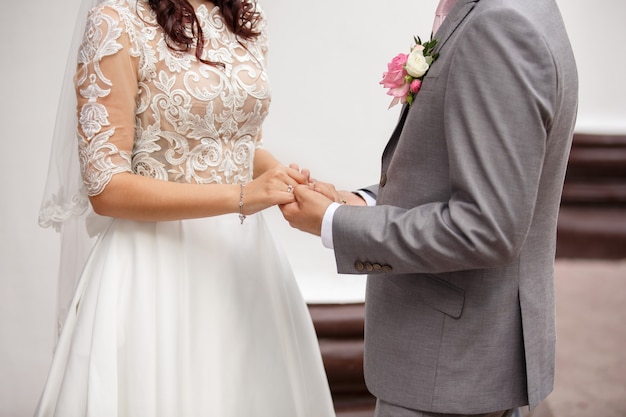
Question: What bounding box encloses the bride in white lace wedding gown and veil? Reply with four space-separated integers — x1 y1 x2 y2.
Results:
36 0 334 417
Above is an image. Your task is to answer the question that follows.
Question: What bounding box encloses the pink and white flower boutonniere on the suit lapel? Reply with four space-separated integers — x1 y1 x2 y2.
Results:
380 36 439 108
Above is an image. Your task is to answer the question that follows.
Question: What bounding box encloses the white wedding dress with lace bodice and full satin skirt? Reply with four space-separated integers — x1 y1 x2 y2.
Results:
36 0 334 417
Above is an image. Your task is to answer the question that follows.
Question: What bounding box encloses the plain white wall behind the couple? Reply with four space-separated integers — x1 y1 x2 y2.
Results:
0 0 626 417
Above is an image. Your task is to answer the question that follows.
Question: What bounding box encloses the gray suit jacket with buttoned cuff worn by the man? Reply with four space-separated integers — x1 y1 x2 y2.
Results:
333 0 578 414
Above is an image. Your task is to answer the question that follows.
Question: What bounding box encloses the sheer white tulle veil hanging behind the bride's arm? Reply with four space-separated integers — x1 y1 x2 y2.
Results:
39 0 111 338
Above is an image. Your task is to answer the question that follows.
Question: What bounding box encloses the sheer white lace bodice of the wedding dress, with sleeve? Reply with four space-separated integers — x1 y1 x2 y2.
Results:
75 0 270 195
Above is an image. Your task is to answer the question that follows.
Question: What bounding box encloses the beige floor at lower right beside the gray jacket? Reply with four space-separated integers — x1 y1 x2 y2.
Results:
525 260 626 417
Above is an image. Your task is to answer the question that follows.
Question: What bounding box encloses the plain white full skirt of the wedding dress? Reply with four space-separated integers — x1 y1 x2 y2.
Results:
36 214 334 417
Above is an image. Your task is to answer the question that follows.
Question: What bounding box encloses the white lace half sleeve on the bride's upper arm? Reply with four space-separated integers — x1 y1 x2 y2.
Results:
75 6 138 196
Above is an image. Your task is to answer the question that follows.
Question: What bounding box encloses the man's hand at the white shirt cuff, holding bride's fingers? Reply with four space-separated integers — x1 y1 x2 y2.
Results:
280 185 332 236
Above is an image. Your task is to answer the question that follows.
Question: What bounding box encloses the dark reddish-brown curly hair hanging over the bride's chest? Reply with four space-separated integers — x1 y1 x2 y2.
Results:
148 0 260 65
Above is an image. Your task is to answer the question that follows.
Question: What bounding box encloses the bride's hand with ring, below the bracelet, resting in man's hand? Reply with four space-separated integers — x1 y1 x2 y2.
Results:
243 165 308 215
